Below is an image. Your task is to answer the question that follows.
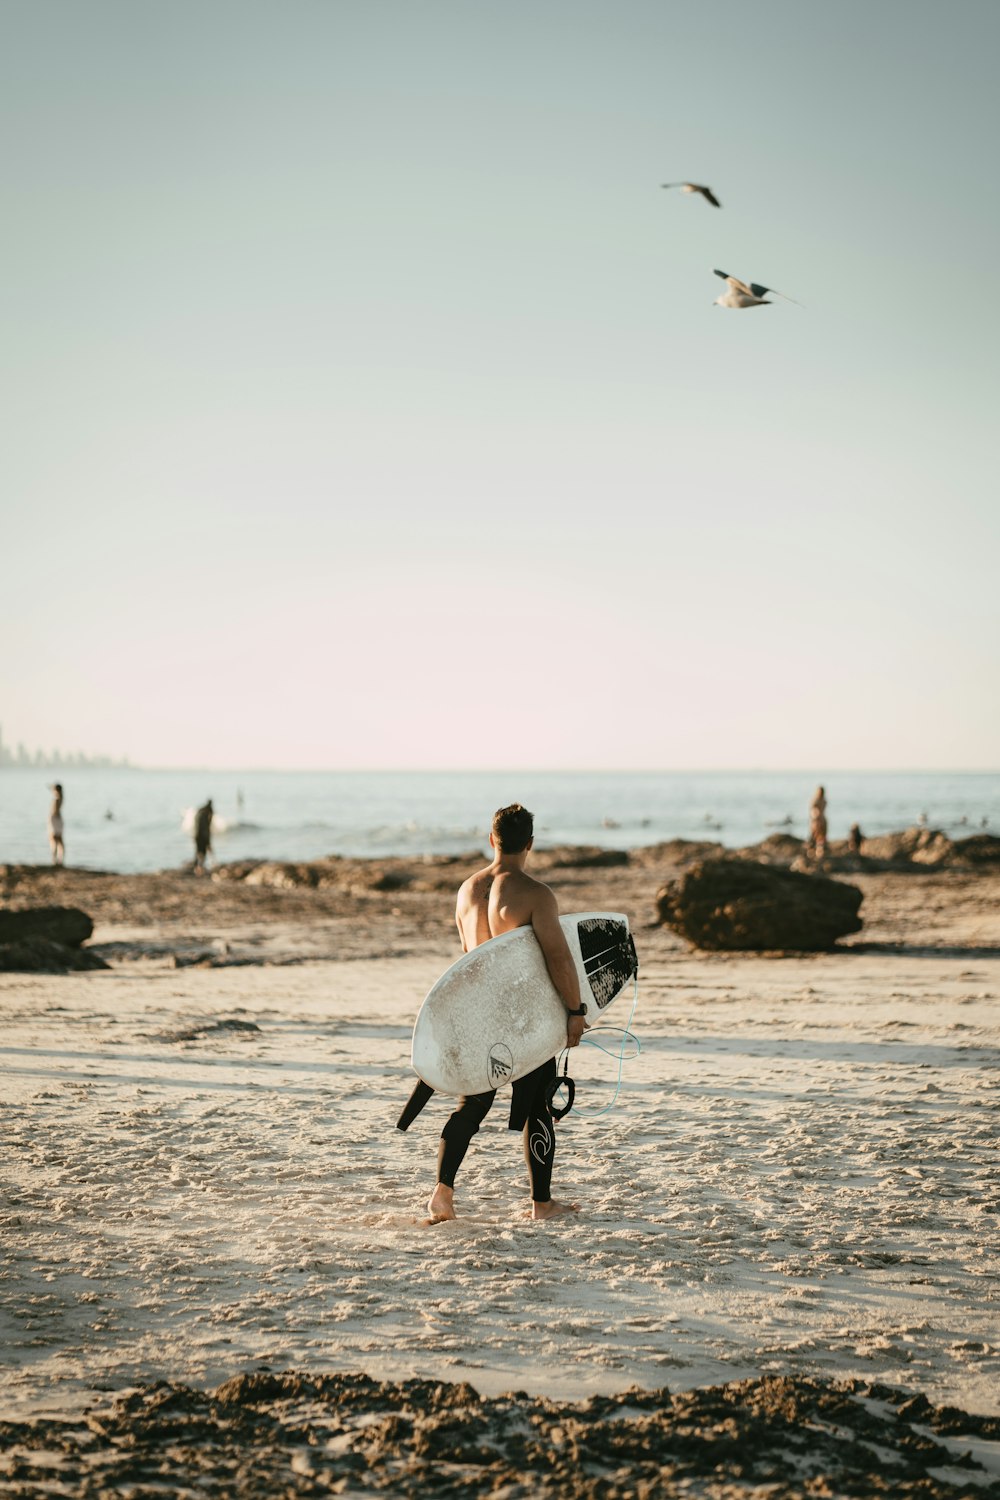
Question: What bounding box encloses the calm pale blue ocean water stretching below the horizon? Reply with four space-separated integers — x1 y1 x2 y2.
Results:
0 767 1000 872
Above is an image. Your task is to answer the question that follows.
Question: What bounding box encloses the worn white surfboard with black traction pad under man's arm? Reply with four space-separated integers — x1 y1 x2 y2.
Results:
412 912 637 1095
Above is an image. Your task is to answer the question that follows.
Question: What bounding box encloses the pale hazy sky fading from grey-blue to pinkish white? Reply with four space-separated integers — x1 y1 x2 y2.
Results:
0 0 1000 770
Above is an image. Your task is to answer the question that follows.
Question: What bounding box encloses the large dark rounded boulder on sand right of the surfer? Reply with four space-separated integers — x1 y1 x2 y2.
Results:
657 858 862 953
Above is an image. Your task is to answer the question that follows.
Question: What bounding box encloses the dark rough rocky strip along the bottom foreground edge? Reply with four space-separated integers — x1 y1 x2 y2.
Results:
0 1371 1000 1500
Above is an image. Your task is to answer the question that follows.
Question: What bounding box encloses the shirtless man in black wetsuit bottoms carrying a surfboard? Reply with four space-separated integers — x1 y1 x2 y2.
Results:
427 803 586 1224
